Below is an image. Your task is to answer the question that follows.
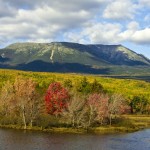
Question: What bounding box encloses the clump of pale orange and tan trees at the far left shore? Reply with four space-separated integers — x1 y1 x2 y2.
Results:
0 77 39 129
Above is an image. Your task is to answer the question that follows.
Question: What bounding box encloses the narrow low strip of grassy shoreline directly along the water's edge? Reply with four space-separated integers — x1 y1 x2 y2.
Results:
0 125 150 134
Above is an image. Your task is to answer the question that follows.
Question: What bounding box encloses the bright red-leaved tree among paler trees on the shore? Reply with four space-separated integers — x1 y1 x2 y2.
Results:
45 82 69 116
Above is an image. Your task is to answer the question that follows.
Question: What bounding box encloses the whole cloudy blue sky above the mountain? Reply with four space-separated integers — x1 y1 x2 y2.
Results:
0 0 150 58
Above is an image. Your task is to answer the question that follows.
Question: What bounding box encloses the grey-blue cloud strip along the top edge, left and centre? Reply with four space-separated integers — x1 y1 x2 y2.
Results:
0 0 106 11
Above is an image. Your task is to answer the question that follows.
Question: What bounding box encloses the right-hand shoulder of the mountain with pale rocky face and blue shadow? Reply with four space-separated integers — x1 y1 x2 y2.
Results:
86 45 150 66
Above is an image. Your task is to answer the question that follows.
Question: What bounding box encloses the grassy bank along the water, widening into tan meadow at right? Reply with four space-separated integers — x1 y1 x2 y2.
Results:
0 115 150 134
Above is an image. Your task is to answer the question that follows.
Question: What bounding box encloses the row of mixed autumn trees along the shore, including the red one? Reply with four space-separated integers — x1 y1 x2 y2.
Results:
0 77 150 129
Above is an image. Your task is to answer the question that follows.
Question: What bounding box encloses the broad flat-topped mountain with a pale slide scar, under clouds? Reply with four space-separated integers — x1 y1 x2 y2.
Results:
0 42 150 74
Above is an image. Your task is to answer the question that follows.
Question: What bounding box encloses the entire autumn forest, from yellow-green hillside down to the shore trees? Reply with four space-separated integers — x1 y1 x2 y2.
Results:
0 69 150 130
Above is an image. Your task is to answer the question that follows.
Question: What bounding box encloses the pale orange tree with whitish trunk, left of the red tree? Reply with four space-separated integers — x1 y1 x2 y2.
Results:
13 78 38 129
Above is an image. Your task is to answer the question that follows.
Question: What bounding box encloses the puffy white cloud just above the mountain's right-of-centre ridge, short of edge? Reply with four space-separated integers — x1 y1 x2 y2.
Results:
65 23 121 44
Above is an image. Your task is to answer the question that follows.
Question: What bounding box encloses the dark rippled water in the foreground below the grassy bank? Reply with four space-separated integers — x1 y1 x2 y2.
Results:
0 129 150 150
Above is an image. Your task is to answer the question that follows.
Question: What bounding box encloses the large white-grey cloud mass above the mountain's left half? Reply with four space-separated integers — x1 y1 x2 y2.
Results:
0 6 95 40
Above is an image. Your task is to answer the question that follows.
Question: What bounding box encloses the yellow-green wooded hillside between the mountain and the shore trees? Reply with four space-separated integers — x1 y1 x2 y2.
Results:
0 69 150 99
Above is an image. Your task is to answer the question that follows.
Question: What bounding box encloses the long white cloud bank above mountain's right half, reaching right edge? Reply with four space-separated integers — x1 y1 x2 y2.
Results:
65 21 150 45
